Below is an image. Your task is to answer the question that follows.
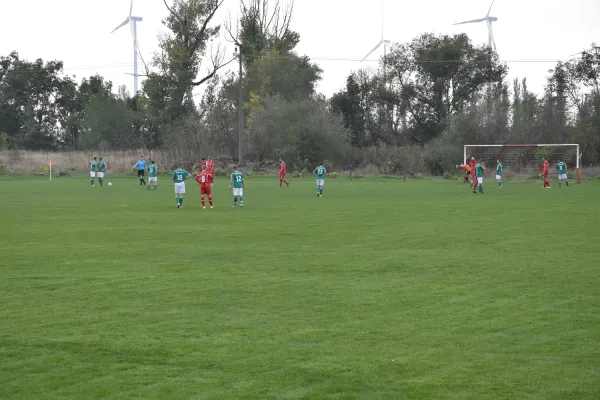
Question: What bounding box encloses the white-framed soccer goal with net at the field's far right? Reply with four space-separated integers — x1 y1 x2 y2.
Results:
463 144 581 183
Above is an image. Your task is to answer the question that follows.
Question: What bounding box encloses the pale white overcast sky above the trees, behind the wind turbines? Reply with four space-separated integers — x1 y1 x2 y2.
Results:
0 0 600 96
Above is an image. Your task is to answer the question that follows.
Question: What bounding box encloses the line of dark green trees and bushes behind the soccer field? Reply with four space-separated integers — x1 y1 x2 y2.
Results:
0 0 600 174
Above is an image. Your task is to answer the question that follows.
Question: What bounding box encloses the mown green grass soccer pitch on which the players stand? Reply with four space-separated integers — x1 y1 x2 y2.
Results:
0 177 600 400
